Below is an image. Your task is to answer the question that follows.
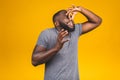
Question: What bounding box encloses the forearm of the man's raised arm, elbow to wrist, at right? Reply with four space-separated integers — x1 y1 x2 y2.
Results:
79 7 101 24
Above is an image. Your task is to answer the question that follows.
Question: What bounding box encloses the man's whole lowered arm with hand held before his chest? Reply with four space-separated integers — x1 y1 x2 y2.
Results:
32 29 68 66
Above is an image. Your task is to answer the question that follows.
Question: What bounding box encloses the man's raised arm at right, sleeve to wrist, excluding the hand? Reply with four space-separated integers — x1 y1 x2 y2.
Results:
80 7 102 34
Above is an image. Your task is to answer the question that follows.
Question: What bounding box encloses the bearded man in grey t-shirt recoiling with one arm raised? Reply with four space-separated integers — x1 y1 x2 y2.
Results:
32 6 101 80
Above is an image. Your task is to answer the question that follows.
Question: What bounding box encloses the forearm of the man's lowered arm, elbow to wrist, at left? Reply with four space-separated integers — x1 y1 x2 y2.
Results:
32 48 59 66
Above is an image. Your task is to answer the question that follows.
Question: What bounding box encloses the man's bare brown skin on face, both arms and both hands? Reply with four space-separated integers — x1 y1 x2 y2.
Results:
32 6 102 66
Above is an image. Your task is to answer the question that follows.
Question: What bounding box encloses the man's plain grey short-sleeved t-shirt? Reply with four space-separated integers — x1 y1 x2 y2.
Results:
37 24 82 80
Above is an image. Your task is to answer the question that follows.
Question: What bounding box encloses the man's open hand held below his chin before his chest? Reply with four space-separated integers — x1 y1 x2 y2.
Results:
55 29 69 50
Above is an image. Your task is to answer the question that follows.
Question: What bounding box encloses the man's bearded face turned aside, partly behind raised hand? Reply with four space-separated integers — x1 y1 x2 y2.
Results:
58 15 75 32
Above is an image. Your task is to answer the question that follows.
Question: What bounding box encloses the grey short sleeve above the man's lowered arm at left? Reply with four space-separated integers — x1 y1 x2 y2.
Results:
37 31 48 48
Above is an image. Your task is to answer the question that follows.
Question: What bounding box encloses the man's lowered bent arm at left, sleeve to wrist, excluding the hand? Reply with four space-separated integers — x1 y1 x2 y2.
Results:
32 45 58 66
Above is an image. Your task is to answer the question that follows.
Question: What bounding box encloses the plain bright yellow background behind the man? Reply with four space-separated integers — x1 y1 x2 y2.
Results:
0 0 120 80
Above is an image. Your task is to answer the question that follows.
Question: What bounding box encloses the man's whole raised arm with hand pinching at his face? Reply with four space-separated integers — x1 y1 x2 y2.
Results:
67 6 102 34
